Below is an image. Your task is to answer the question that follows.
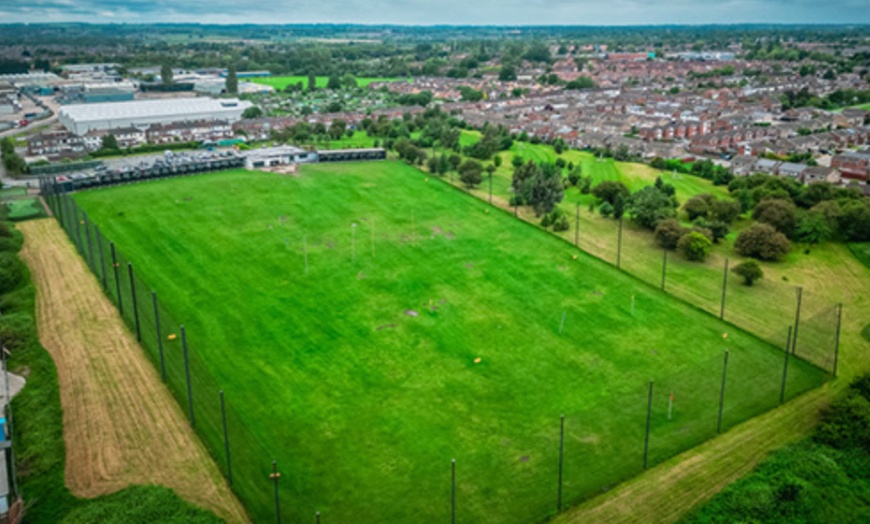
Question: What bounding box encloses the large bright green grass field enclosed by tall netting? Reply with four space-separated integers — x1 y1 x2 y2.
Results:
75 164 824 523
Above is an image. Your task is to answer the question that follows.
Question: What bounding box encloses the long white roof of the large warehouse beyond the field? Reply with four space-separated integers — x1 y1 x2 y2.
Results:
60 97 252 122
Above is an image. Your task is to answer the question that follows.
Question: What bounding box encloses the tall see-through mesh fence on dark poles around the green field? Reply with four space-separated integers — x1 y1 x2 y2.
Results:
43 177 840 522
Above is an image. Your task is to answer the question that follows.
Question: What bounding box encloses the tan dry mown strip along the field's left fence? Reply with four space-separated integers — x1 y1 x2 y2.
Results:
18 219 248 522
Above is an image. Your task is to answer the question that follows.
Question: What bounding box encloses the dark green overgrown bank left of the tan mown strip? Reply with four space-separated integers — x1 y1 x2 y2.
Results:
0 219 227 524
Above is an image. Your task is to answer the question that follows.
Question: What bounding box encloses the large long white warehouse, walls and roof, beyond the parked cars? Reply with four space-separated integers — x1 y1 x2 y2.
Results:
58 98 253 136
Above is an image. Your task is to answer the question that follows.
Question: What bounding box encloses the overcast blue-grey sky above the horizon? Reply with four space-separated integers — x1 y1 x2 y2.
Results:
0 0 870 25
